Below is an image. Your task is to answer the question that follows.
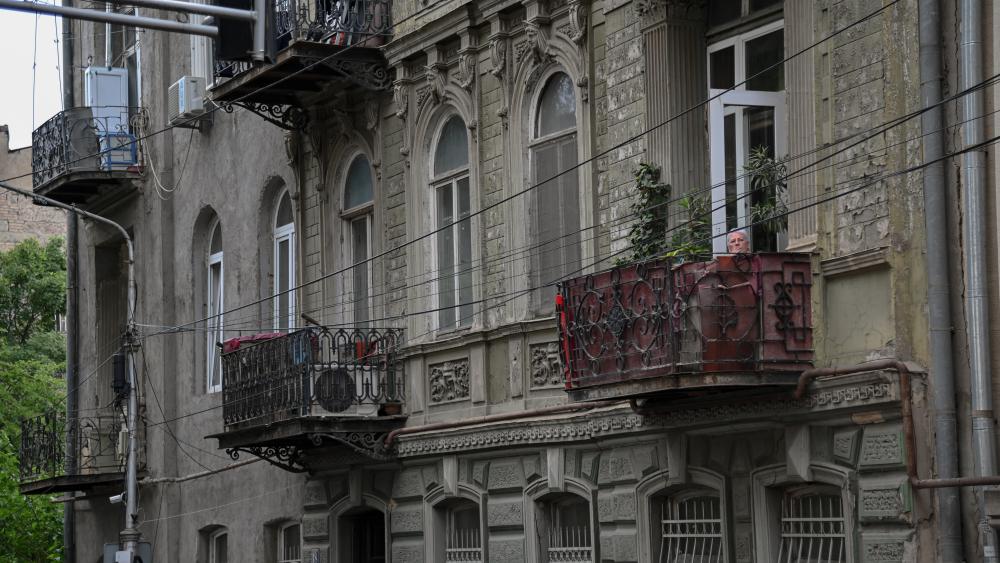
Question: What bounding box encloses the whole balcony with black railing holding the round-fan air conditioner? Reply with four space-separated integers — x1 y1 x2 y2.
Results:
210 328 406 471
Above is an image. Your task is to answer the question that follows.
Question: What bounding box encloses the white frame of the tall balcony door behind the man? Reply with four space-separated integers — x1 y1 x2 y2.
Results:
707 19 788 254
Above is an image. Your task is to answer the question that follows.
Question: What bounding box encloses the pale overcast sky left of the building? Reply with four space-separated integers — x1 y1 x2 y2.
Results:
0 10 62 148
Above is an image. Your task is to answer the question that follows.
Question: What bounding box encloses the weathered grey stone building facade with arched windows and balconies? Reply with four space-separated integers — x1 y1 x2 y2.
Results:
17 0 1000 563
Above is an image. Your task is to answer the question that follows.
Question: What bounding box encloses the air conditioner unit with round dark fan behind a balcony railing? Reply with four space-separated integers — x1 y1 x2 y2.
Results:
310 364 378 417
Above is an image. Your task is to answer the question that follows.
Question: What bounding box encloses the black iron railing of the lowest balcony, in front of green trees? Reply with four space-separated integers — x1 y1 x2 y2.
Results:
18 409 125 483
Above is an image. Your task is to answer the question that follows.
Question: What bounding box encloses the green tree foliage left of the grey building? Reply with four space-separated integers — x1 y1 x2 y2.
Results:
0 240 66 563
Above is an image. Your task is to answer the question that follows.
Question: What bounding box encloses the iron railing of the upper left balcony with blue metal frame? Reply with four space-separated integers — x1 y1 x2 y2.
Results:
31 106 142 190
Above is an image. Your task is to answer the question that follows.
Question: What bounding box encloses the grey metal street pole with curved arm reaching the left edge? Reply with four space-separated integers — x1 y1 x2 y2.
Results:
0 182 140 558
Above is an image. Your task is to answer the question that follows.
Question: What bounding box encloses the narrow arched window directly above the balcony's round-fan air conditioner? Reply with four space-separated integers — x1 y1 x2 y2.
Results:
343 155 375 325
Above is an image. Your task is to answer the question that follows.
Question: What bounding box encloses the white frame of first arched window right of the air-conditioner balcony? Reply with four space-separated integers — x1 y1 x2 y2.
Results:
427 113 477 332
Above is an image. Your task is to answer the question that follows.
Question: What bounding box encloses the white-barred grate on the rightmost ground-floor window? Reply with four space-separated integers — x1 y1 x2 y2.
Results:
778 493 847 563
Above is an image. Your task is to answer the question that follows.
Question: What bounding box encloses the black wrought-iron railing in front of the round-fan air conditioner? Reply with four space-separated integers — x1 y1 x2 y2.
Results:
222 328 404 431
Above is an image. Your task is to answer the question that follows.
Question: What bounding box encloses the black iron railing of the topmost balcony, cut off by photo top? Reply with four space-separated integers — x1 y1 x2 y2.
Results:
215 0 392 78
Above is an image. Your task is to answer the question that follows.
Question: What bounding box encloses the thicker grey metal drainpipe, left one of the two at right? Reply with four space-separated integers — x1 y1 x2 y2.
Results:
918 0 963 563
